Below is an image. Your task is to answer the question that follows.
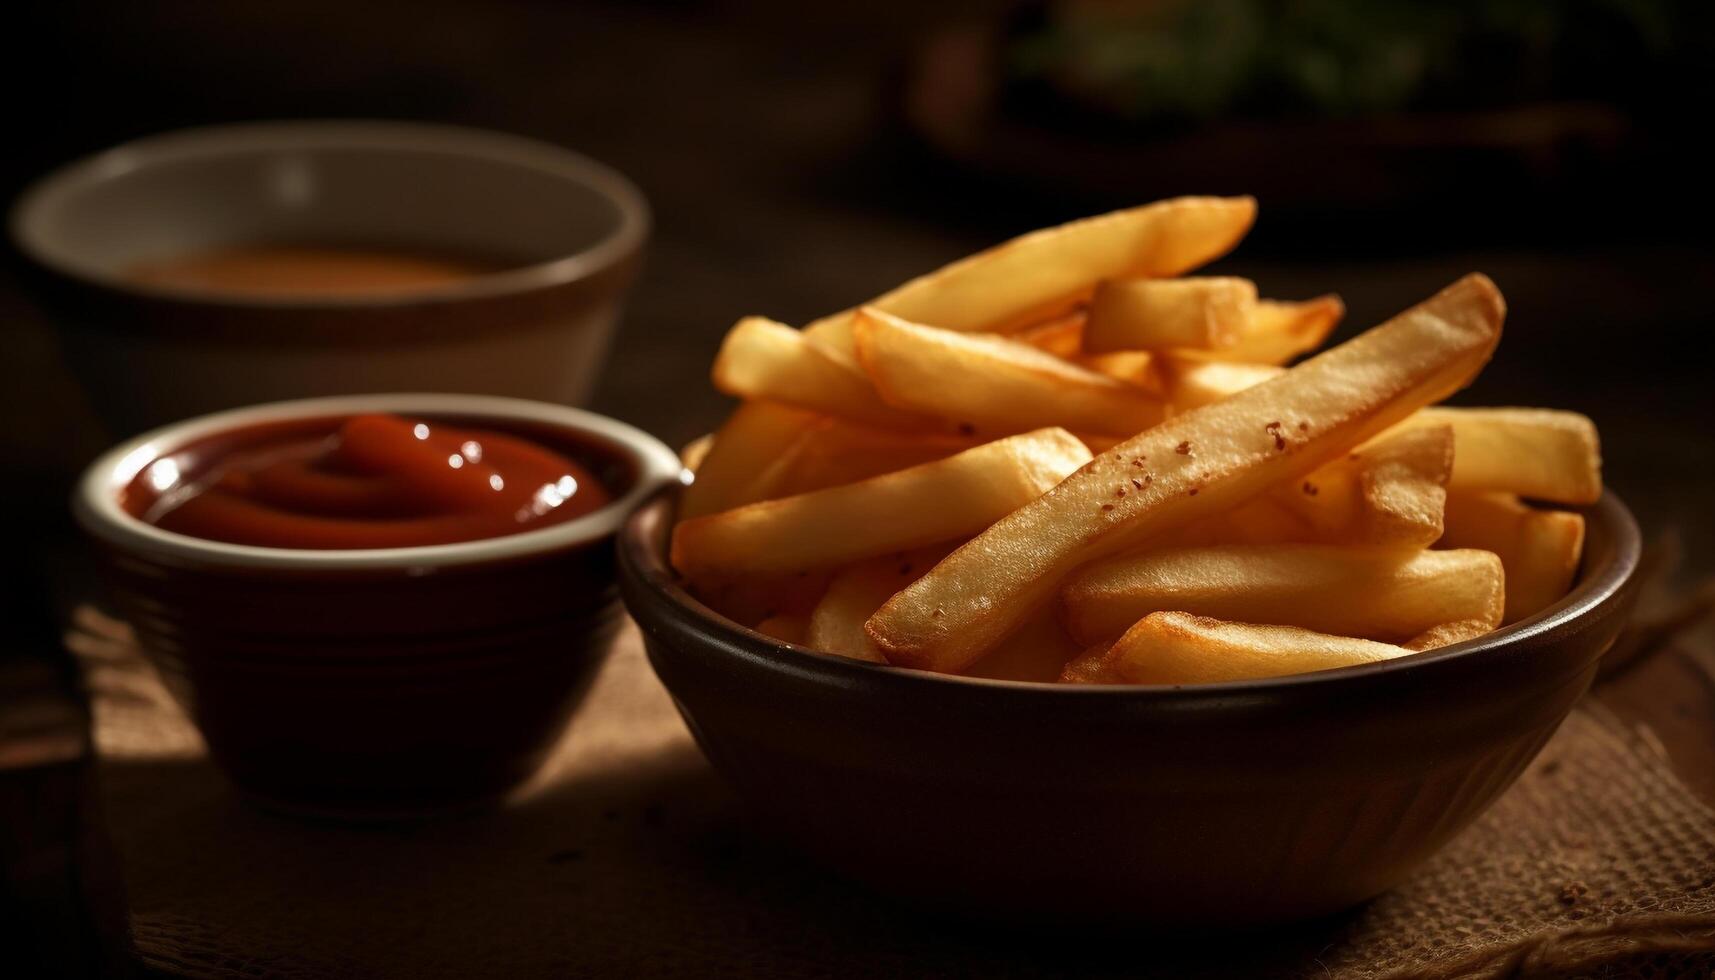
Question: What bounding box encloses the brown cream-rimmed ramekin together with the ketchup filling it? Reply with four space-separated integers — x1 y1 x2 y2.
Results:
74 395 681 819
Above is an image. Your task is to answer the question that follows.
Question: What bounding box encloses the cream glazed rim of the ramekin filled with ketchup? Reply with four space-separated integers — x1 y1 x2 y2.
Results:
72 393 684 572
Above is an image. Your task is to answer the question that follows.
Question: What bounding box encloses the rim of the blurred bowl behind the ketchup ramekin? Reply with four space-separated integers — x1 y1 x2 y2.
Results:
7 118 652 311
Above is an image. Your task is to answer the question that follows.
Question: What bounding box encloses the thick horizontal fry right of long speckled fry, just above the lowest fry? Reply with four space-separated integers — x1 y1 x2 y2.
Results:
1060 544 1506 644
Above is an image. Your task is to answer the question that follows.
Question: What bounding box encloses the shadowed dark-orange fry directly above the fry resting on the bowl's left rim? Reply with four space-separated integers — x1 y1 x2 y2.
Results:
768 419 976 503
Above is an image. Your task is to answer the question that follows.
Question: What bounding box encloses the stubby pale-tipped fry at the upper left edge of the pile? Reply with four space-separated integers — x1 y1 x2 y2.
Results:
712 316 936 433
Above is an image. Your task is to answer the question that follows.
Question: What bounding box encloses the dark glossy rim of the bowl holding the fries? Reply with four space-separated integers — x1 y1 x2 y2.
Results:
619 489 1643 705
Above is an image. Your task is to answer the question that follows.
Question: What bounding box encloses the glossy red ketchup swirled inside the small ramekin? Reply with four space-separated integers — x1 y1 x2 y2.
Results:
134 415 612 549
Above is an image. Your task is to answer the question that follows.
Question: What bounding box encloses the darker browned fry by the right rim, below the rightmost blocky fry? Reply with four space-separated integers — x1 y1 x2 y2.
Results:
1441 493 1585 623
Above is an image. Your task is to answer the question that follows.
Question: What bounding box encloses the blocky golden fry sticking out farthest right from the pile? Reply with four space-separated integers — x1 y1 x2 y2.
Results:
1401 407 1602 505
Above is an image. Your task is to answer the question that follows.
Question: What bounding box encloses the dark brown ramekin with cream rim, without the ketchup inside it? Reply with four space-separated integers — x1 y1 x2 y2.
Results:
74 395 681 817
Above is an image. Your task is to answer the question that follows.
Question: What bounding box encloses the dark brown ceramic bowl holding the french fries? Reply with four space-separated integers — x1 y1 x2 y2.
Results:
619 494 1638 925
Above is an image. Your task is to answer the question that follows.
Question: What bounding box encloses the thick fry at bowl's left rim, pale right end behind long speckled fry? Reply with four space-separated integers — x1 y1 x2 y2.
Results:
671 429 1089 578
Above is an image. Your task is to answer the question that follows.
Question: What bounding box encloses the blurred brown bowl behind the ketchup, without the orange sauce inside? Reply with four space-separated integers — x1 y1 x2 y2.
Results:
10 122 650 434
